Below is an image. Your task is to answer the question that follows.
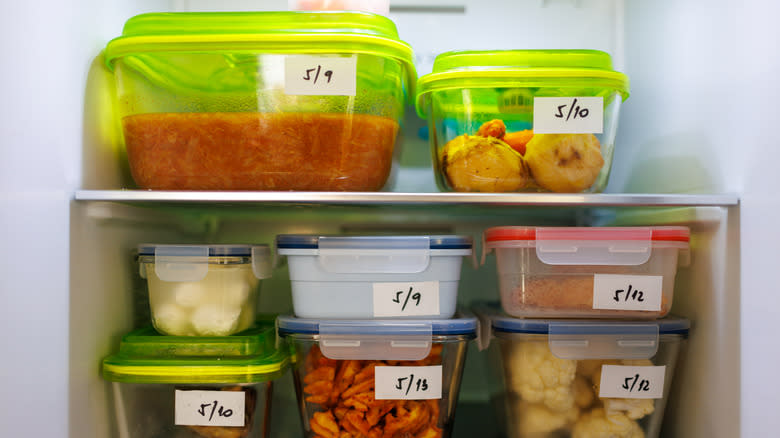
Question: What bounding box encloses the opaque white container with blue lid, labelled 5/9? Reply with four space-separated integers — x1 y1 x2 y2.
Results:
276 235 472 319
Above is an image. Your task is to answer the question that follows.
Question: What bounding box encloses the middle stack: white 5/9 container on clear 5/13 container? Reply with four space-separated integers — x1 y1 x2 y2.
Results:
276 235 477 438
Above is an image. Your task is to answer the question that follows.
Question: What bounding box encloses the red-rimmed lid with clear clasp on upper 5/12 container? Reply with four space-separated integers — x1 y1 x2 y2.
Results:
482 226 690 266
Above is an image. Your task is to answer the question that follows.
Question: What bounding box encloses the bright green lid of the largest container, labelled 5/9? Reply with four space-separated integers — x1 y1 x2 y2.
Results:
105 11 417 96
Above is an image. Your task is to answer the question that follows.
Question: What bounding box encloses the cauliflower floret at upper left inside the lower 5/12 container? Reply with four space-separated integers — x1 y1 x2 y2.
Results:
507 341 577 412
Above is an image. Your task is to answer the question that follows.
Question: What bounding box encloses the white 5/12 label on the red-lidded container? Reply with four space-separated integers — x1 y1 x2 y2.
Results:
593 274 663 312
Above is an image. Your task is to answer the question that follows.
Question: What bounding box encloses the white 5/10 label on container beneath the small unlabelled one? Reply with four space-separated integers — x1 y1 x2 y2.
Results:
174 389 246 427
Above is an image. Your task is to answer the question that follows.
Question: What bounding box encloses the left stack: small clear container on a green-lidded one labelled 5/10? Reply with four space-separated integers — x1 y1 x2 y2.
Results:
103 245 289 438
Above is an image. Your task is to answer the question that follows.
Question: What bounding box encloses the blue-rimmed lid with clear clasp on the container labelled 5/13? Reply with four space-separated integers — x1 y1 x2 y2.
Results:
277 316 478 360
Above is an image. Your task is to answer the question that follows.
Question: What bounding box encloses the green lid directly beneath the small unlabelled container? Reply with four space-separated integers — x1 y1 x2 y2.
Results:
103 322 289 383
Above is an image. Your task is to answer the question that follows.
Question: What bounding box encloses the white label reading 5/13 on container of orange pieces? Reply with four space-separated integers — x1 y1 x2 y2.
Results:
374 365 442 400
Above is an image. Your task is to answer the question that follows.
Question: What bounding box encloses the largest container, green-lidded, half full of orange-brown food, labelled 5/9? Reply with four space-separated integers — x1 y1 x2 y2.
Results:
105 12 417 191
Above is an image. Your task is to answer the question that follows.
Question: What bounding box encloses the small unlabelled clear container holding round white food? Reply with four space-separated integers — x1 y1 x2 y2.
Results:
138 244 271 336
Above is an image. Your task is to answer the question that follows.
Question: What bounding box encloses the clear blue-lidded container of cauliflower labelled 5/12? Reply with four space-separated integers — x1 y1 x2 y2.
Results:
479 302 690 438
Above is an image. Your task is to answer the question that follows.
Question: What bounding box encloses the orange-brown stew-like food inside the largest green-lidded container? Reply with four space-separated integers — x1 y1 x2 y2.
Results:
122 112 399 191
